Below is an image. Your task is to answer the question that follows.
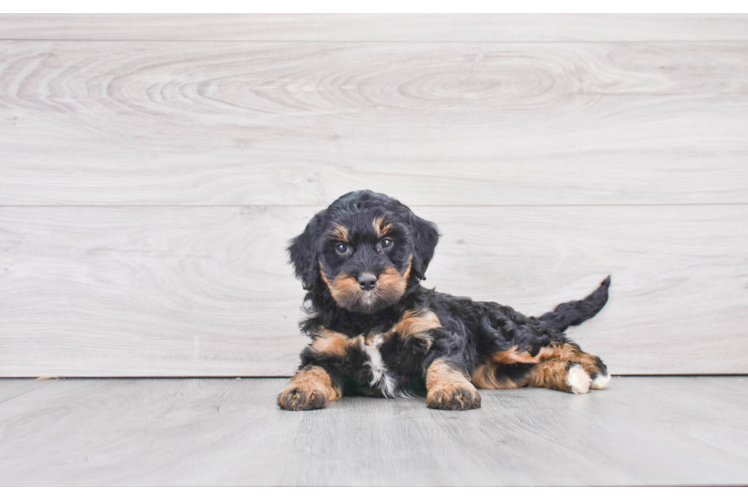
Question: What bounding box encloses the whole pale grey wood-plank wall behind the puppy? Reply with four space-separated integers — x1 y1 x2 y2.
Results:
0 14 748 377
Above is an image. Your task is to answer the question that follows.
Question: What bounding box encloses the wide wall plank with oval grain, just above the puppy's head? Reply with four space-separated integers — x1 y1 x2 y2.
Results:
0 42 748 205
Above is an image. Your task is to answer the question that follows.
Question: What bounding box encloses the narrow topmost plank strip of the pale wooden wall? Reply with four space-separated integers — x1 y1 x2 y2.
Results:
0 14 748 42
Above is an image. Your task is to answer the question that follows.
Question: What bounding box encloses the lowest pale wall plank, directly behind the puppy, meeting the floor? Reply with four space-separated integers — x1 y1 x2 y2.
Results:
0 205 748 376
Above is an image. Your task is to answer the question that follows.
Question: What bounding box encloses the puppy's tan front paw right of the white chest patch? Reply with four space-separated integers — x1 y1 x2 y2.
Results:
426 358 480 410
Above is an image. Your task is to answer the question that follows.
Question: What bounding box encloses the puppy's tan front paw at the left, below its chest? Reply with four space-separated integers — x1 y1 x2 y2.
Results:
278 365 342 411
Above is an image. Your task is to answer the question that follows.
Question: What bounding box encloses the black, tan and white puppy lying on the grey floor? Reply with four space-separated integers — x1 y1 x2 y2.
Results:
278 191 610 410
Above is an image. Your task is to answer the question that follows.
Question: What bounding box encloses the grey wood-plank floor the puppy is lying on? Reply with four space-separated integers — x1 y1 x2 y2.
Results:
0 377 748 486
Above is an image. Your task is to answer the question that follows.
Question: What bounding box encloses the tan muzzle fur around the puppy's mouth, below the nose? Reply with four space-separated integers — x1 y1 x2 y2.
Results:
320 266 410 314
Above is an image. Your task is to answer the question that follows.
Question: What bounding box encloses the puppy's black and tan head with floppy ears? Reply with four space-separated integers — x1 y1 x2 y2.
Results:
288 191 439 313
